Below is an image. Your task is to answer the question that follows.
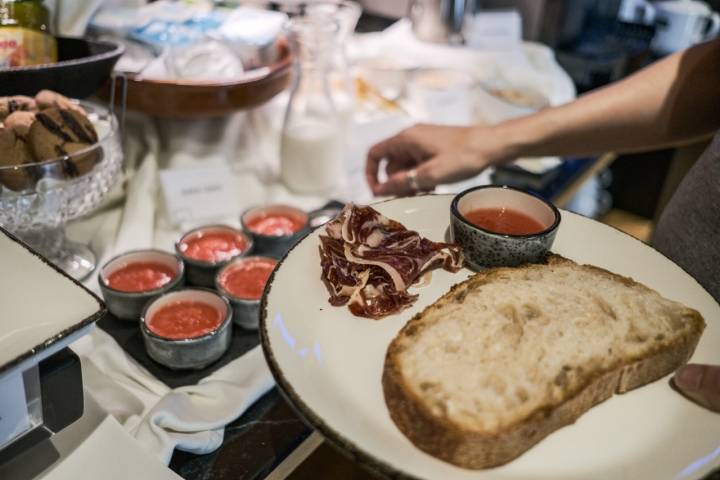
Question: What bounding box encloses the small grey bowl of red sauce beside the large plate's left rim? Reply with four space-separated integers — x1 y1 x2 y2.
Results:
215 257 277 330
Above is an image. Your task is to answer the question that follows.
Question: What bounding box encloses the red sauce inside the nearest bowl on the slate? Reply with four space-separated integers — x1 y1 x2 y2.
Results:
146 300 223 340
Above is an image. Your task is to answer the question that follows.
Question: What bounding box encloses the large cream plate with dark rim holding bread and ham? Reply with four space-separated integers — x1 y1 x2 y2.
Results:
261 195 720 480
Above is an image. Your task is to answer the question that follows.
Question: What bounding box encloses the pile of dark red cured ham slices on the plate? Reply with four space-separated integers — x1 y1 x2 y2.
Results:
320 204 463 319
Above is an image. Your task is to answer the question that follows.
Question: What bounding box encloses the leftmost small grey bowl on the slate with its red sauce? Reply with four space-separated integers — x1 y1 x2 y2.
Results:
98 249 185 321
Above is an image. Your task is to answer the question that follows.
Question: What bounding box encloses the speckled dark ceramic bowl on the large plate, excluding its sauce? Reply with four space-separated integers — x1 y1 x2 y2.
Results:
450 185 561 270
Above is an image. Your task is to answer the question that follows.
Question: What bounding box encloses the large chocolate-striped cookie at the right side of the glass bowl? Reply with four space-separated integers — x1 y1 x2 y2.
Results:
28 108 100 177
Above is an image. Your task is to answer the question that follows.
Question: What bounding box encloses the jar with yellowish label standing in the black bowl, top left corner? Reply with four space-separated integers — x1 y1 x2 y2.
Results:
0 0 57 68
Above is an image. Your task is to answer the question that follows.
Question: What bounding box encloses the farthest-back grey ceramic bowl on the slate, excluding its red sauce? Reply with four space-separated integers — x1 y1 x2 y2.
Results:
240 205 310 259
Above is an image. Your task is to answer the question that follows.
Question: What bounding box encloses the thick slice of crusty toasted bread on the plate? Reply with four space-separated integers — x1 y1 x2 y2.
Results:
382 256 705 469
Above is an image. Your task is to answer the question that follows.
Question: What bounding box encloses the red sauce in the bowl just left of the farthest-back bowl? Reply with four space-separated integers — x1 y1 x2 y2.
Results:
179 229 249 263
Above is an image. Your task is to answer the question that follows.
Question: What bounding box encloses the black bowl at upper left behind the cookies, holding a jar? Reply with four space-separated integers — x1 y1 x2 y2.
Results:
0 37 125 98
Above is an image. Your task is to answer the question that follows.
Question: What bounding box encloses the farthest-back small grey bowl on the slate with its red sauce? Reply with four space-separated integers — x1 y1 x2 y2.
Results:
240 205 310 258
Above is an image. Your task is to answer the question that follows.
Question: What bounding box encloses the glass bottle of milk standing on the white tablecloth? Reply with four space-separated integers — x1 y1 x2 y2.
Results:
280 16 344 193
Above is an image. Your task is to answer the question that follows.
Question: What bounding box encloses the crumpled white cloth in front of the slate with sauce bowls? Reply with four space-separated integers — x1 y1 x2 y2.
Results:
73 329 274 465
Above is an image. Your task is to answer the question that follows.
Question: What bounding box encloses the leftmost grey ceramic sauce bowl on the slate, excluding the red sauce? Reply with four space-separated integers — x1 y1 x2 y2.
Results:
98 250 185 321
